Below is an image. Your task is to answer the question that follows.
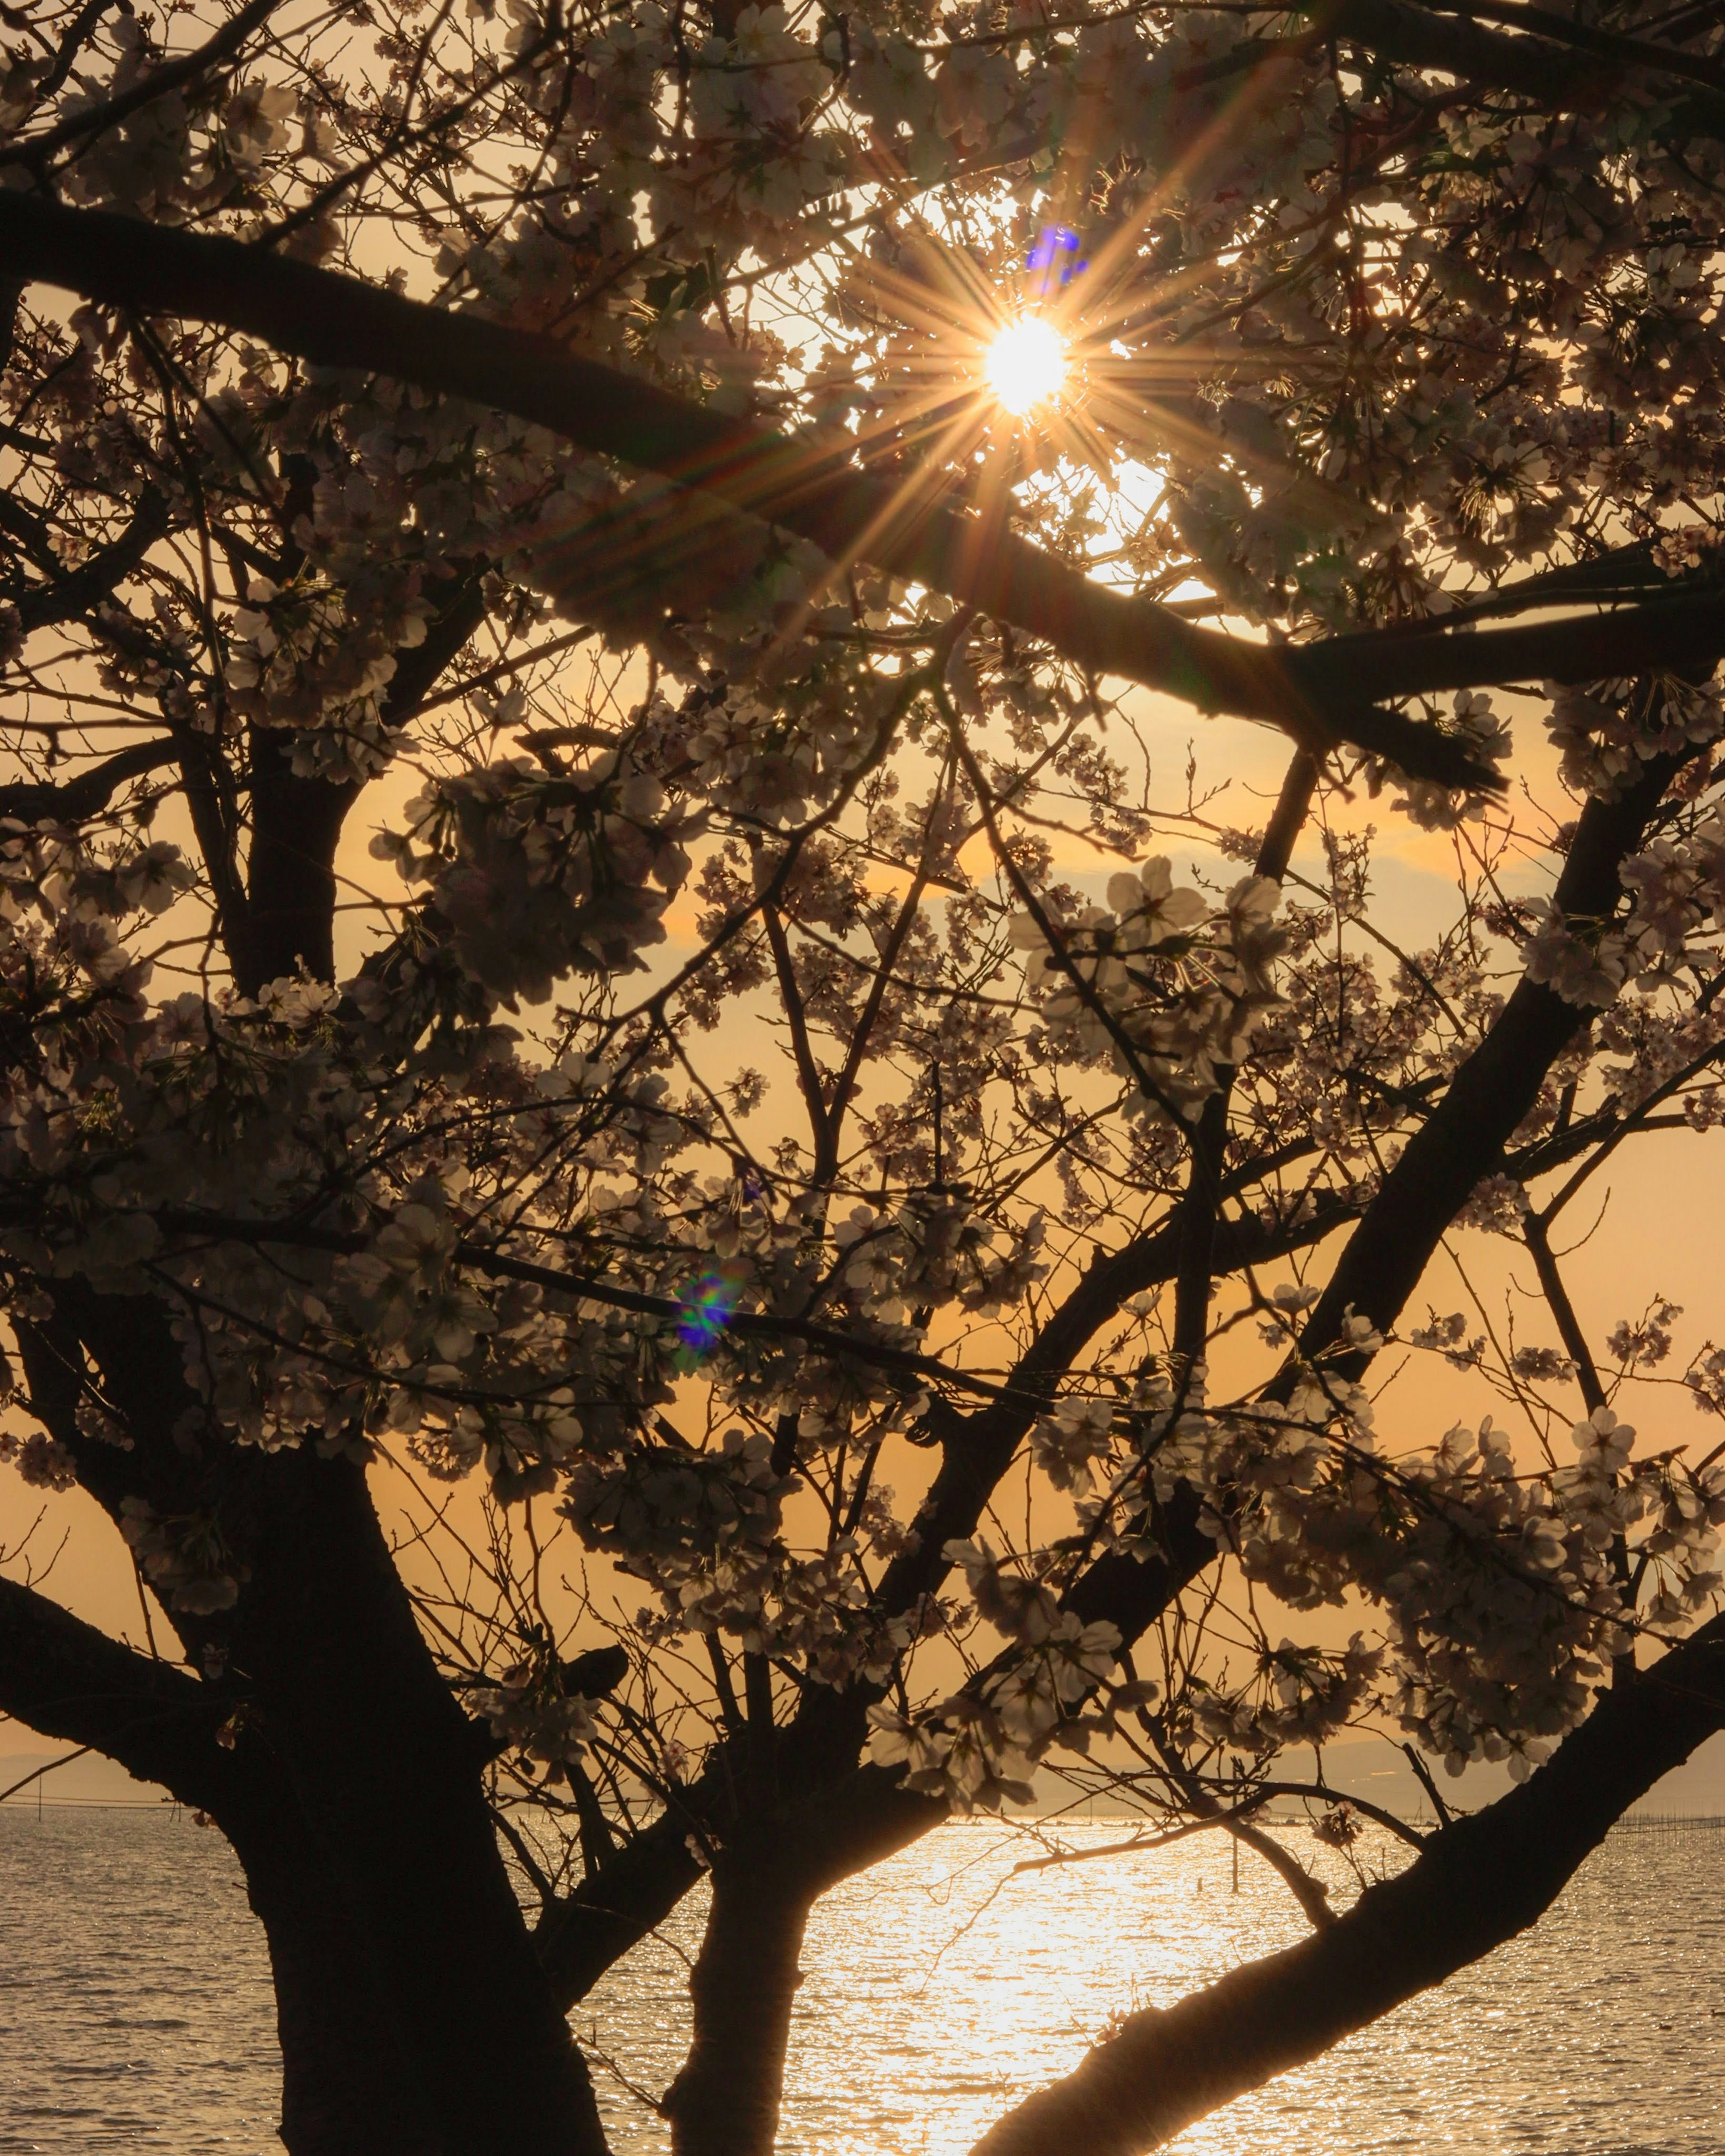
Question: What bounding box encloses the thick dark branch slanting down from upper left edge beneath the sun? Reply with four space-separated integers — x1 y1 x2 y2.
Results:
0 192 1496 787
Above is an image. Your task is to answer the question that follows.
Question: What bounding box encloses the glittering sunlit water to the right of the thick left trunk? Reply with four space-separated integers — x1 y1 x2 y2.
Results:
578 1820 1725 2156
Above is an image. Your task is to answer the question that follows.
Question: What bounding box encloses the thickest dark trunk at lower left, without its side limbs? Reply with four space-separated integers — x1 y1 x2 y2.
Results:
235 1453 604 2156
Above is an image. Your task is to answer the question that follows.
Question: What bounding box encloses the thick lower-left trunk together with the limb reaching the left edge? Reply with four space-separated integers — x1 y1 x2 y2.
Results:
0 1283 606 2156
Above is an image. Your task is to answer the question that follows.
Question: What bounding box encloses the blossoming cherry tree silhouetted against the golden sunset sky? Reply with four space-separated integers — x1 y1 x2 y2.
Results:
0 0 1725 2156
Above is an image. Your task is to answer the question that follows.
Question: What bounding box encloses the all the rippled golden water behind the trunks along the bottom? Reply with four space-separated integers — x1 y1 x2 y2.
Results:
0 1807 1725 2156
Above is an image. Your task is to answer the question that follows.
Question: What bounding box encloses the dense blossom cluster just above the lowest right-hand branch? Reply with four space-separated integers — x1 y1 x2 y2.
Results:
1156 1375 1725 1776
